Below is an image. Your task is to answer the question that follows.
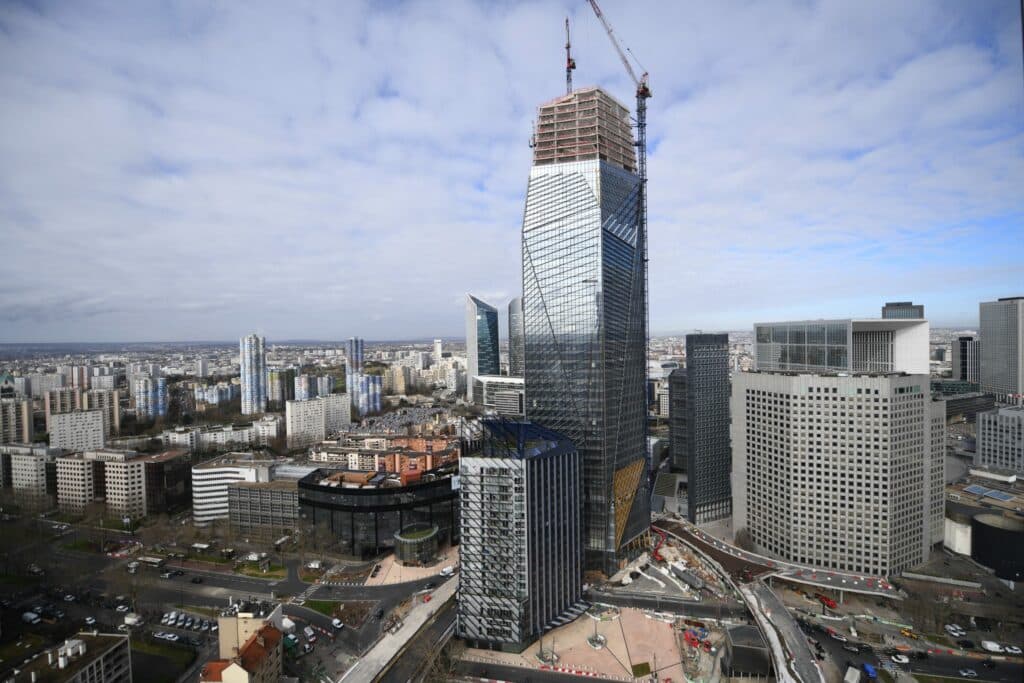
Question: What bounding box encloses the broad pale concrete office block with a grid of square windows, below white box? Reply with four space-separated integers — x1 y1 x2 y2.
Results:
731 372 945 575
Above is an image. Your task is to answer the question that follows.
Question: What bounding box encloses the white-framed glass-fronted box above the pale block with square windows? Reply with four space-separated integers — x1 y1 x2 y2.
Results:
754 318 931 375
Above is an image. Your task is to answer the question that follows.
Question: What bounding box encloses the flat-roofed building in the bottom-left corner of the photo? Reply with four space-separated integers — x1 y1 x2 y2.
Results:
17 631 133 683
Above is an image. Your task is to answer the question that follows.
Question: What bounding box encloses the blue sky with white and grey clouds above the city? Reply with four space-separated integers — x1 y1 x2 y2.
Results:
0 0 1024 342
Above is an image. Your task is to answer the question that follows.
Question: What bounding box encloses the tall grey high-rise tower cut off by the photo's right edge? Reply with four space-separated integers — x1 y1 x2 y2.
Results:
978 297 1024 402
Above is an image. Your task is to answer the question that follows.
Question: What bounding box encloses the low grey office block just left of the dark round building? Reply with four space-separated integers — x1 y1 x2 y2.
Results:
227 479 299 541
